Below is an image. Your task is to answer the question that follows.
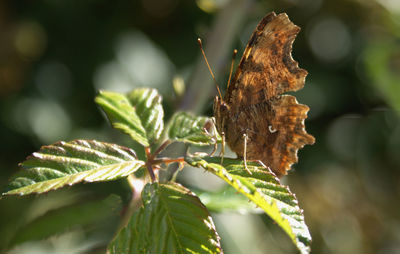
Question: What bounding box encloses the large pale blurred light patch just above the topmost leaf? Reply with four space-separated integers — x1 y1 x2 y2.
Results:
94 31 175 93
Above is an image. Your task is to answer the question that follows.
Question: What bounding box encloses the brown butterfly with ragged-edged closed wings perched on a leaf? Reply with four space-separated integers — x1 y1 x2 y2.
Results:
214 12 315 176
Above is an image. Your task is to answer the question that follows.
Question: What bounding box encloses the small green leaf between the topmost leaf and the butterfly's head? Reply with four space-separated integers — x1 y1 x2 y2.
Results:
167 112 221 145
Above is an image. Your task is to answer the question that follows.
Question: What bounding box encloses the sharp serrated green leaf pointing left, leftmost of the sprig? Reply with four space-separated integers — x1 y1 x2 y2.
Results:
3 140 145 195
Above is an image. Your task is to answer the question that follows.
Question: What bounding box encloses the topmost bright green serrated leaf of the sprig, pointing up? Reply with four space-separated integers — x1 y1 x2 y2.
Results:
95 88 164 147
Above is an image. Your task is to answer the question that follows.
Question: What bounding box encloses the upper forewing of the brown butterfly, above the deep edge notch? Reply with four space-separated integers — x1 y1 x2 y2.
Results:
224 12 307 110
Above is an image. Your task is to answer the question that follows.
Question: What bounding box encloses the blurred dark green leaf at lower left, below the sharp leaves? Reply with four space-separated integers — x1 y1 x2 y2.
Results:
8 195 121 247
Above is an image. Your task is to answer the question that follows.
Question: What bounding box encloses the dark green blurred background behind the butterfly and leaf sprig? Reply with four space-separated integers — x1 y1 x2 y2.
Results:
0 0 400 254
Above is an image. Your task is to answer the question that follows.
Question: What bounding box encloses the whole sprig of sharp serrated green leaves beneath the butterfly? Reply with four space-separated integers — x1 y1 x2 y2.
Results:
3 88 311 253
